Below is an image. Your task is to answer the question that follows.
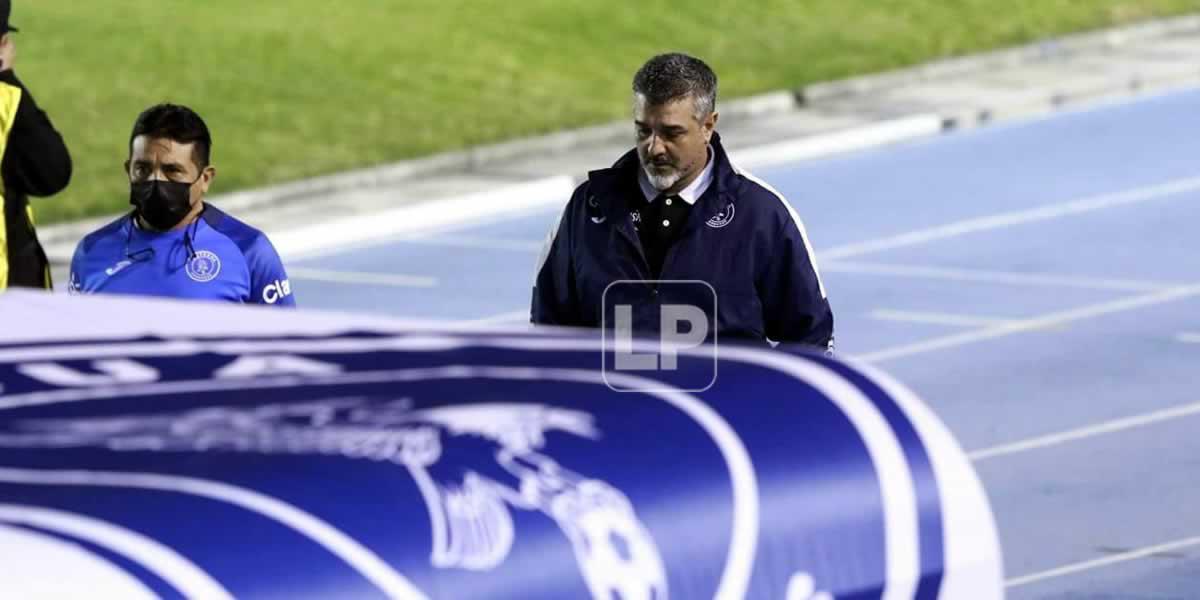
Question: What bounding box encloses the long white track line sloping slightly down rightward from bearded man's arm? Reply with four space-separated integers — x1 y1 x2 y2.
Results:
821 262 1178 292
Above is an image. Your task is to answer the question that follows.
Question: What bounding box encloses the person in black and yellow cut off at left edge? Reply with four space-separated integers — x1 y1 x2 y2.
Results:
0 0 71 290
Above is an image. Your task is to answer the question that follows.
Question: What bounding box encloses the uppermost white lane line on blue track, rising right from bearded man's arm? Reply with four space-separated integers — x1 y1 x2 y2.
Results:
817 172 1200 260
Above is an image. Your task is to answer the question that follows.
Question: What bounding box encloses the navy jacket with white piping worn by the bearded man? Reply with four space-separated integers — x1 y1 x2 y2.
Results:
530 133 833 349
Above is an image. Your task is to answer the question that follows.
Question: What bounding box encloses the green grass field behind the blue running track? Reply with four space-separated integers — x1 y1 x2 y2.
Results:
12 0 1200 222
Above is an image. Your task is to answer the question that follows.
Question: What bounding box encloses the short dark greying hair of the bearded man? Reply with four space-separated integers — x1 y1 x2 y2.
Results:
634 53 716 119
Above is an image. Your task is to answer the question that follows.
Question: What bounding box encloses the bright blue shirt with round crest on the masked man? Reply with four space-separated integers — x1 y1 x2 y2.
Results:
70 205 295 306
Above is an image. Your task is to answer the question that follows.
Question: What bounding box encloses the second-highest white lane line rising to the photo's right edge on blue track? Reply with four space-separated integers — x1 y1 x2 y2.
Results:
857 284 1200 362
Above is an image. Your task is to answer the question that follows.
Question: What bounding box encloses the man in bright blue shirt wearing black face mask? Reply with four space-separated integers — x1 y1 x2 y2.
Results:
71 104 295 306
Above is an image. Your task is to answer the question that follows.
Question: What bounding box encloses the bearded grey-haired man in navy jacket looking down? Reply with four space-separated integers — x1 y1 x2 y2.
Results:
530 54 833 350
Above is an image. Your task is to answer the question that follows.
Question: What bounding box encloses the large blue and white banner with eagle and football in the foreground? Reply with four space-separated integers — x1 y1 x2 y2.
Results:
0 293 1003 600
